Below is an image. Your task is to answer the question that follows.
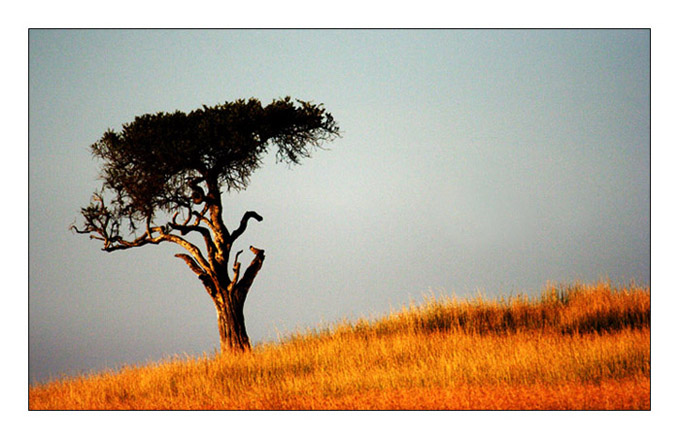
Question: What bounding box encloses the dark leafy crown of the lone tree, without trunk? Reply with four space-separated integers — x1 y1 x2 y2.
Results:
83 98 338 232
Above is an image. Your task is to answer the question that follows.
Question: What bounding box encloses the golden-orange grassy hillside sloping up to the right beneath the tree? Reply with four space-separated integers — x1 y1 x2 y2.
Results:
29 284 651 409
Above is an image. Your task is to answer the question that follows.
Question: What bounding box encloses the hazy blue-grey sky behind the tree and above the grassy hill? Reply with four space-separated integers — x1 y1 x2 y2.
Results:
29 30 650 380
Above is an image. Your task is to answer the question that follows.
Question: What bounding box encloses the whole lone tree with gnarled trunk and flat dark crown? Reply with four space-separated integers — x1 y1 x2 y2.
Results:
72 98 339 352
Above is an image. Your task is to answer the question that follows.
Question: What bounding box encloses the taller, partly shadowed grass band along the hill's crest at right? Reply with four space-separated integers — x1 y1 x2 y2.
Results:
351 283 650 335
